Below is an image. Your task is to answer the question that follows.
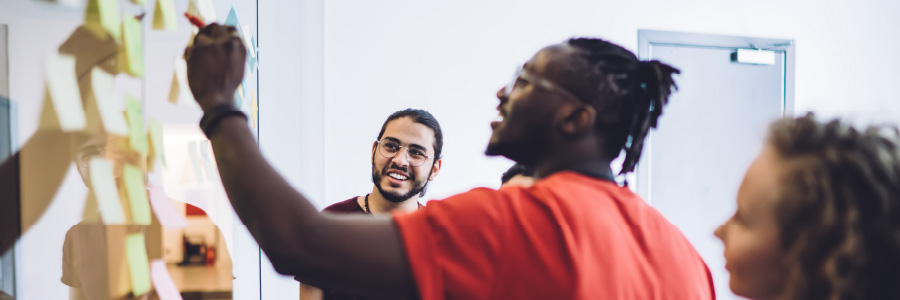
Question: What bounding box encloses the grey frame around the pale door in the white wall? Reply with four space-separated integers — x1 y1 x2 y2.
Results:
635 29 795 205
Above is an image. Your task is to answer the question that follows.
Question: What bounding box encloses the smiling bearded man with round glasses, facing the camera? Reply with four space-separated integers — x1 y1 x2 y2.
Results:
300 109 444 300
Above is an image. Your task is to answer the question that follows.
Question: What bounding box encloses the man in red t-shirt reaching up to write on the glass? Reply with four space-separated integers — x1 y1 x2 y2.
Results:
185 25 715 300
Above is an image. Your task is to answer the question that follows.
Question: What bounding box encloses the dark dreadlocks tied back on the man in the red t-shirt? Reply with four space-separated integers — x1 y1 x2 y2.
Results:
564 38 680 174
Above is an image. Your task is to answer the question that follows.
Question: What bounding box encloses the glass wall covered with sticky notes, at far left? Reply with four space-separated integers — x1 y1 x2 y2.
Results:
0 0 259 299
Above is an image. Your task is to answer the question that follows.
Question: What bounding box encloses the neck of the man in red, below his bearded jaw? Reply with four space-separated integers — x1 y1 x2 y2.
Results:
534 139 615 178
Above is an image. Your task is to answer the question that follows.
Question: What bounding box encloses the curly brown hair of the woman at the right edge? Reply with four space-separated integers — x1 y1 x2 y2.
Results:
768 113 900 300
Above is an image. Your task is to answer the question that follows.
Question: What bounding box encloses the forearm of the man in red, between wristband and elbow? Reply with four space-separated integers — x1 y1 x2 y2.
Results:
211 117 321 273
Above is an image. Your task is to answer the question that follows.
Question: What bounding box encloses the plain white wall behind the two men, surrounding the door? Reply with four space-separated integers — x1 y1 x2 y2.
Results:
316 0 900 203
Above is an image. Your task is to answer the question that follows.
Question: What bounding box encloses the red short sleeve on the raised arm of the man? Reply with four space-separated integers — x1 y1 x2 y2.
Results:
394 188 510 300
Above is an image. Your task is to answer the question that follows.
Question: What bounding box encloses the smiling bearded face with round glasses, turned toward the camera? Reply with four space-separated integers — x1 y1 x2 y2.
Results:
372 117 440 202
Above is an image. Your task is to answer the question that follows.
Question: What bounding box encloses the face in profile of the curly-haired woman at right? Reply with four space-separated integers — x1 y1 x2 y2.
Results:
715 146 788 299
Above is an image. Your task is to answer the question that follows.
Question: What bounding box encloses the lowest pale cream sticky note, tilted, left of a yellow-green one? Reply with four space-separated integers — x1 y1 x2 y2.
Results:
88 158 125 225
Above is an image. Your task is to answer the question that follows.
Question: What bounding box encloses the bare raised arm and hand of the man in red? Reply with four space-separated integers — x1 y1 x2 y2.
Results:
185 24 415 296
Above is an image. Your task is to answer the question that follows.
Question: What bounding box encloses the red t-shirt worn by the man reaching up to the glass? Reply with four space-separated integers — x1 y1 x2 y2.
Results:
393 172 715 300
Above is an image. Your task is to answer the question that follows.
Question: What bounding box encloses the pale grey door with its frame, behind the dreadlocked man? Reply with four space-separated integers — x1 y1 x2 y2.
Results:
637 30 793 299
